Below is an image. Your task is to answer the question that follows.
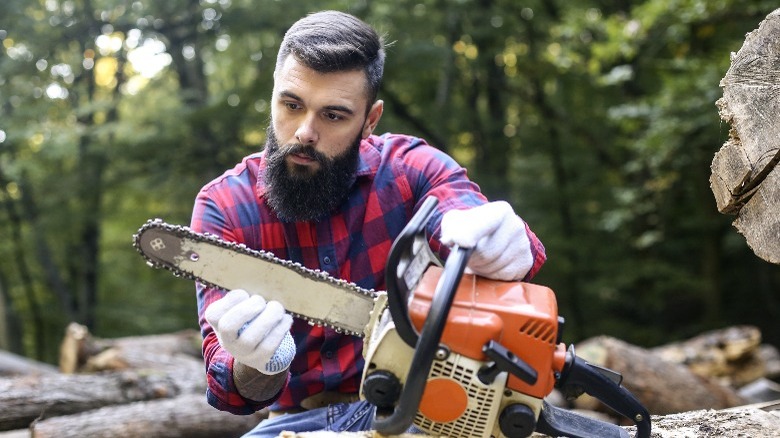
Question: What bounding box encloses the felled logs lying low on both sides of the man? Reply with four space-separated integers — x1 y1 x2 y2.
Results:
0 324 780 438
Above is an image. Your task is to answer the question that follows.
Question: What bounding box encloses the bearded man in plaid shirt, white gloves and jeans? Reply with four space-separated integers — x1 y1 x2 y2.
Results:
191 11 545 436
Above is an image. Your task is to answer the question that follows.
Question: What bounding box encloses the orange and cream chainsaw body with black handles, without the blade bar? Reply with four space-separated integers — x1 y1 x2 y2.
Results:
361 196 650 438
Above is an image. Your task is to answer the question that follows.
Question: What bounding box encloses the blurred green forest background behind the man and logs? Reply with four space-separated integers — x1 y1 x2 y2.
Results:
0 0 780 362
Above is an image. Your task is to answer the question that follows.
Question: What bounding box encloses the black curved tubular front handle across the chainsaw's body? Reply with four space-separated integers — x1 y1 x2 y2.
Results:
372 198 473 435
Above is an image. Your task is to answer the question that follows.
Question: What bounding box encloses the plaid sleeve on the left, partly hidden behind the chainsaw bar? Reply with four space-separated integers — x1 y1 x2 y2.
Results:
190 186 289 415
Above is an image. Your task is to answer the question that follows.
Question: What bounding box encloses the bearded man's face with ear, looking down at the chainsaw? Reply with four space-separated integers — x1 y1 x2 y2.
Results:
265 56 382 221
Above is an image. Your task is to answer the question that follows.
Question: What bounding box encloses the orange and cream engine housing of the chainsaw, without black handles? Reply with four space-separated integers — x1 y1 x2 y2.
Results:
361 266 563 437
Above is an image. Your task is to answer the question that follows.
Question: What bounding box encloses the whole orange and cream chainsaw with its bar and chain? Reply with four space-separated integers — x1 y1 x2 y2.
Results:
133 197 651 438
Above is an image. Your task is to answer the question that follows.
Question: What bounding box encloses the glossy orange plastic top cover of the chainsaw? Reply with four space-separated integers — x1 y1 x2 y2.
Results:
408 266 566 399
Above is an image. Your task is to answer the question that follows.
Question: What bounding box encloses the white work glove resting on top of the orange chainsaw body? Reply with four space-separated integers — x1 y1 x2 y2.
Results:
441 201 534 281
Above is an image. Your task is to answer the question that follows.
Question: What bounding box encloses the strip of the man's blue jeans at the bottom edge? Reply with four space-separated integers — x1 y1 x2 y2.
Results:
244 400 420 438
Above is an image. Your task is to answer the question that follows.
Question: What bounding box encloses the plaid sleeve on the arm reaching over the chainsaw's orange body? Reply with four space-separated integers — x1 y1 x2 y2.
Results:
388 136 547 281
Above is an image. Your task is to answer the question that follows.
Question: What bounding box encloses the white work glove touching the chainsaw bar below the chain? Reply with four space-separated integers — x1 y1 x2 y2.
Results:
205 289 295 375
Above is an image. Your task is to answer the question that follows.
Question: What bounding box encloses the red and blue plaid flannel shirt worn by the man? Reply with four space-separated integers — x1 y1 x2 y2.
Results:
191 134 545 414
